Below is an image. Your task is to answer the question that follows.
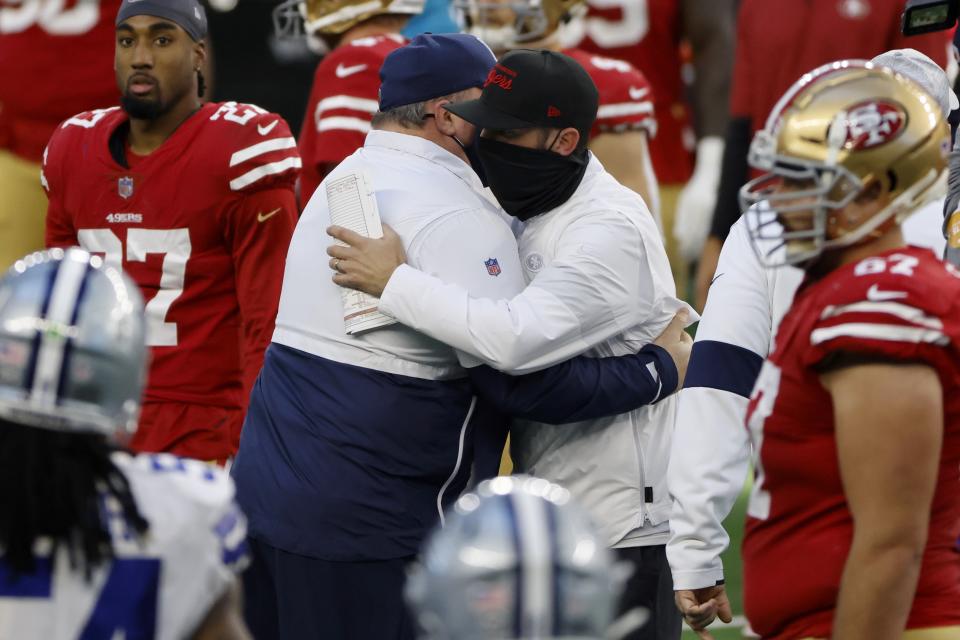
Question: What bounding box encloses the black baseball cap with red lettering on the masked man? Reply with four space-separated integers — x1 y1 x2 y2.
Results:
445 49 600 140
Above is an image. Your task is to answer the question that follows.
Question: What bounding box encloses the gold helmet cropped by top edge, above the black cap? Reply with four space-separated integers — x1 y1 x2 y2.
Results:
453 0 586 52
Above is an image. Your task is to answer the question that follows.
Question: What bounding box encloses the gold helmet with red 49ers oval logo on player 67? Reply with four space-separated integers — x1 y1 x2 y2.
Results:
740 60 950 266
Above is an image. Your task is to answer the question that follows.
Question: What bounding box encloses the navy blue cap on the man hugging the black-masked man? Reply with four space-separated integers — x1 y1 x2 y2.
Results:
380 33 497 111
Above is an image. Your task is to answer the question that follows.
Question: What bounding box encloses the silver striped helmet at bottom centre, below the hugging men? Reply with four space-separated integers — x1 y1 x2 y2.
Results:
406 476 629 640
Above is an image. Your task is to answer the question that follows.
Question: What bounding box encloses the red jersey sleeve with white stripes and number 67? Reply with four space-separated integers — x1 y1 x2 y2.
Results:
804 248 960 386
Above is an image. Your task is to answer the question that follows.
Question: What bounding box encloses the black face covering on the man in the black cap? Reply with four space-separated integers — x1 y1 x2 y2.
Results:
480 138 589 220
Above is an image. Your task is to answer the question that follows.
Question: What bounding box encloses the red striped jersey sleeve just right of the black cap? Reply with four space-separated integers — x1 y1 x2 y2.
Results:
563 49 657 138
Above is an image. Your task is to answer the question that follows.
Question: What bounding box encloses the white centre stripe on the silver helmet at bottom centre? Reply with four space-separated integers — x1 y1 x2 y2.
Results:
510 492 554 638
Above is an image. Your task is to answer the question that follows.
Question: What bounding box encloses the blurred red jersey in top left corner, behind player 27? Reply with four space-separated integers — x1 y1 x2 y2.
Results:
0 0 120 162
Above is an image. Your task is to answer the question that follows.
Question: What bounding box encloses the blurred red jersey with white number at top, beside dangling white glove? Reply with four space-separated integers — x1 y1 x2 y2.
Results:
565 0 694 185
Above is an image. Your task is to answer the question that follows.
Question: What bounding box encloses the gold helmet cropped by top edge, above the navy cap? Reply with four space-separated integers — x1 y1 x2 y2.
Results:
273 0 426 38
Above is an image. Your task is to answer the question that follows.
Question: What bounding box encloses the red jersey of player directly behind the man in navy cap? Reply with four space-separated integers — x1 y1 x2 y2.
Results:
300 34 407 206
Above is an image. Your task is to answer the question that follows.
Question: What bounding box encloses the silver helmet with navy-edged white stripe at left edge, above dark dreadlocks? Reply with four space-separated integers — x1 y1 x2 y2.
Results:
0 249 147 437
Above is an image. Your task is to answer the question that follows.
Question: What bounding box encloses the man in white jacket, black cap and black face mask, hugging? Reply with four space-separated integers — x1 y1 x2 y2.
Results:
328 50 696 640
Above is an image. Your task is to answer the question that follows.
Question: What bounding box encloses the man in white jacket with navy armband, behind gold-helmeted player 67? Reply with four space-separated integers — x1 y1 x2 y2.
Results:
667 49 957 638
